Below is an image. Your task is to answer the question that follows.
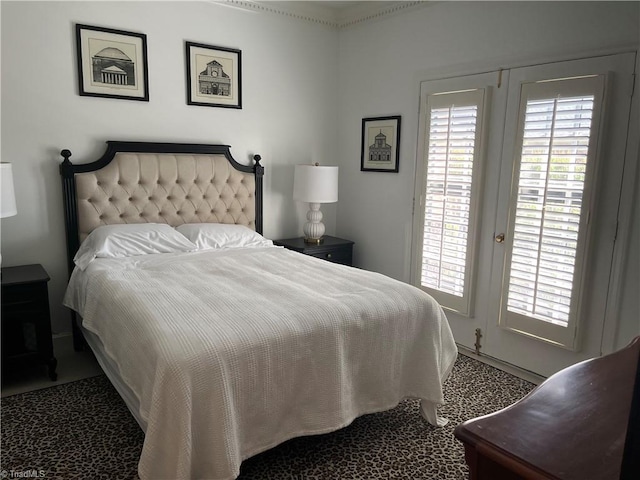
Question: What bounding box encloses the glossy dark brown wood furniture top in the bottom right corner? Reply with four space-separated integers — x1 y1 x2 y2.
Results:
455 337 640 480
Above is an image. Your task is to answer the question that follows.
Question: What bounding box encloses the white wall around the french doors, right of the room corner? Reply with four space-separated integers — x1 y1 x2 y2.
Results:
337 2 640 346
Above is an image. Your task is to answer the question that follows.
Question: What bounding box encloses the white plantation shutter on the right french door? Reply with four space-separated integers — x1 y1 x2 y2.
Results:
500 76 604 345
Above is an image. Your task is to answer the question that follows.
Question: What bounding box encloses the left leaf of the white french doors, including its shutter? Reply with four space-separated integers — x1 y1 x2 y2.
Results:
412 71 509 349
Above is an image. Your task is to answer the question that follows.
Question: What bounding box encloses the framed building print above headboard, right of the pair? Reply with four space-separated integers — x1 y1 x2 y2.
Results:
186 42 242 108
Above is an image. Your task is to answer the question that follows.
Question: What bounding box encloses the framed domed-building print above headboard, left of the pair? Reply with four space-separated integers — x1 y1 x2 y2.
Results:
76 24 149 102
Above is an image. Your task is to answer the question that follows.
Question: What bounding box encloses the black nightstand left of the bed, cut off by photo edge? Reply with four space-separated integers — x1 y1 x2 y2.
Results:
2 265 58 381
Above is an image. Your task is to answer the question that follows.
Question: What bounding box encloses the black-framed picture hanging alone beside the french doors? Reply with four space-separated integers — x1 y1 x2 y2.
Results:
360 115 400 172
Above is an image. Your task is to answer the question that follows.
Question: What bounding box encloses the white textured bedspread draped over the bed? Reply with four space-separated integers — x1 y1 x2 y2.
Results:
65 247 457 480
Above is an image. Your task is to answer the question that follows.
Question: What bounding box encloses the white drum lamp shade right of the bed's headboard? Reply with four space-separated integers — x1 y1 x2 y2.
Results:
293 165 338 203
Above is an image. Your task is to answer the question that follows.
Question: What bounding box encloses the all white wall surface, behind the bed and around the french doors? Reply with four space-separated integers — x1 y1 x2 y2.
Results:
0 0 640 344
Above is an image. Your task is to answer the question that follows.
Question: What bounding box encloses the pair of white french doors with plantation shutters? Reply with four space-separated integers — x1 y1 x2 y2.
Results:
412 53 635 376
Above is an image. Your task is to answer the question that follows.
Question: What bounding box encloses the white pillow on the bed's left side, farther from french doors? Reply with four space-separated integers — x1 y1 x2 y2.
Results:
73 223 196 270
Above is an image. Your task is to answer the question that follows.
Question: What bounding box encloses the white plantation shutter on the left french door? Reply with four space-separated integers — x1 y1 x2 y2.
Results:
420 90 485 315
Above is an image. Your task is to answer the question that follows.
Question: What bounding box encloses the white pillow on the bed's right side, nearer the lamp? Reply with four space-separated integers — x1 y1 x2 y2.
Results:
176 223 273 250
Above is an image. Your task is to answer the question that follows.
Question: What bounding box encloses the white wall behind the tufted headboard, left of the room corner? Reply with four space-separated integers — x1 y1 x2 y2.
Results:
1 1 337 332
